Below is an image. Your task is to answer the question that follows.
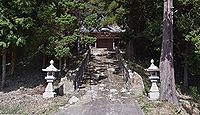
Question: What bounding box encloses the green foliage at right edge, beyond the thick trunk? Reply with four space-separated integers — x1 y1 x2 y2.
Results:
175 0 200 76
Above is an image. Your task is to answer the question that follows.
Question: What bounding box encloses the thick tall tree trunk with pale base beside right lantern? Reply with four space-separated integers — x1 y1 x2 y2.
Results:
160 0 178 105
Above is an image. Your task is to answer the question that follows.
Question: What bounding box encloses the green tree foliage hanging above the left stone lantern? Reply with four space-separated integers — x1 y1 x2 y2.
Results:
34 0 95 59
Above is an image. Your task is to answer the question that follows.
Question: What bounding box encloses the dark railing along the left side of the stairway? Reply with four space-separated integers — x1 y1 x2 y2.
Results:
74 48 91 90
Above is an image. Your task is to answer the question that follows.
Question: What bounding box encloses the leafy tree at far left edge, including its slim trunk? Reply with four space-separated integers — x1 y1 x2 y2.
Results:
0 1 28 88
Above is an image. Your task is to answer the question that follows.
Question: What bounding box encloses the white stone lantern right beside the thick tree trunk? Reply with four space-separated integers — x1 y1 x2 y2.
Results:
146 59 160 100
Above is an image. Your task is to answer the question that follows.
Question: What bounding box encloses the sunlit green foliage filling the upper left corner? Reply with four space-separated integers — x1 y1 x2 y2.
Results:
0 0 35 48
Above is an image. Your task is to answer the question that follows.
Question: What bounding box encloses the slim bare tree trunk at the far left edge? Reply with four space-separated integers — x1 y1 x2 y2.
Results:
1 50 6 88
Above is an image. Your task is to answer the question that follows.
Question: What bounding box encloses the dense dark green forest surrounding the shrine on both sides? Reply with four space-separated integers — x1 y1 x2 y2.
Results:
0 0 200 96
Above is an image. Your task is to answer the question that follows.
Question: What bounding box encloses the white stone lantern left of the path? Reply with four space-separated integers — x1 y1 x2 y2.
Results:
42 60 60 98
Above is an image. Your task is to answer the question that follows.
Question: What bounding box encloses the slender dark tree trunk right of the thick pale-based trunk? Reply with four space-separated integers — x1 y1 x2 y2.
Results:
183 47 188 93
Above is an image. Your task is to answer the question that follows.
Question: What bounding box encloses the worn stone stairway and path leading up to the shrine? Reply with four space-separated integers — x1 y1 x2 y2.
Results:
56 49 143 115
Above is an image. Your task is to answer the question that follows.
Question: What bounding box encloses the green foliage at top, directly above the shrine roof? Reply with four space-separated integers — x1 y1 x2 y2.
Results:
89 0 125 27
